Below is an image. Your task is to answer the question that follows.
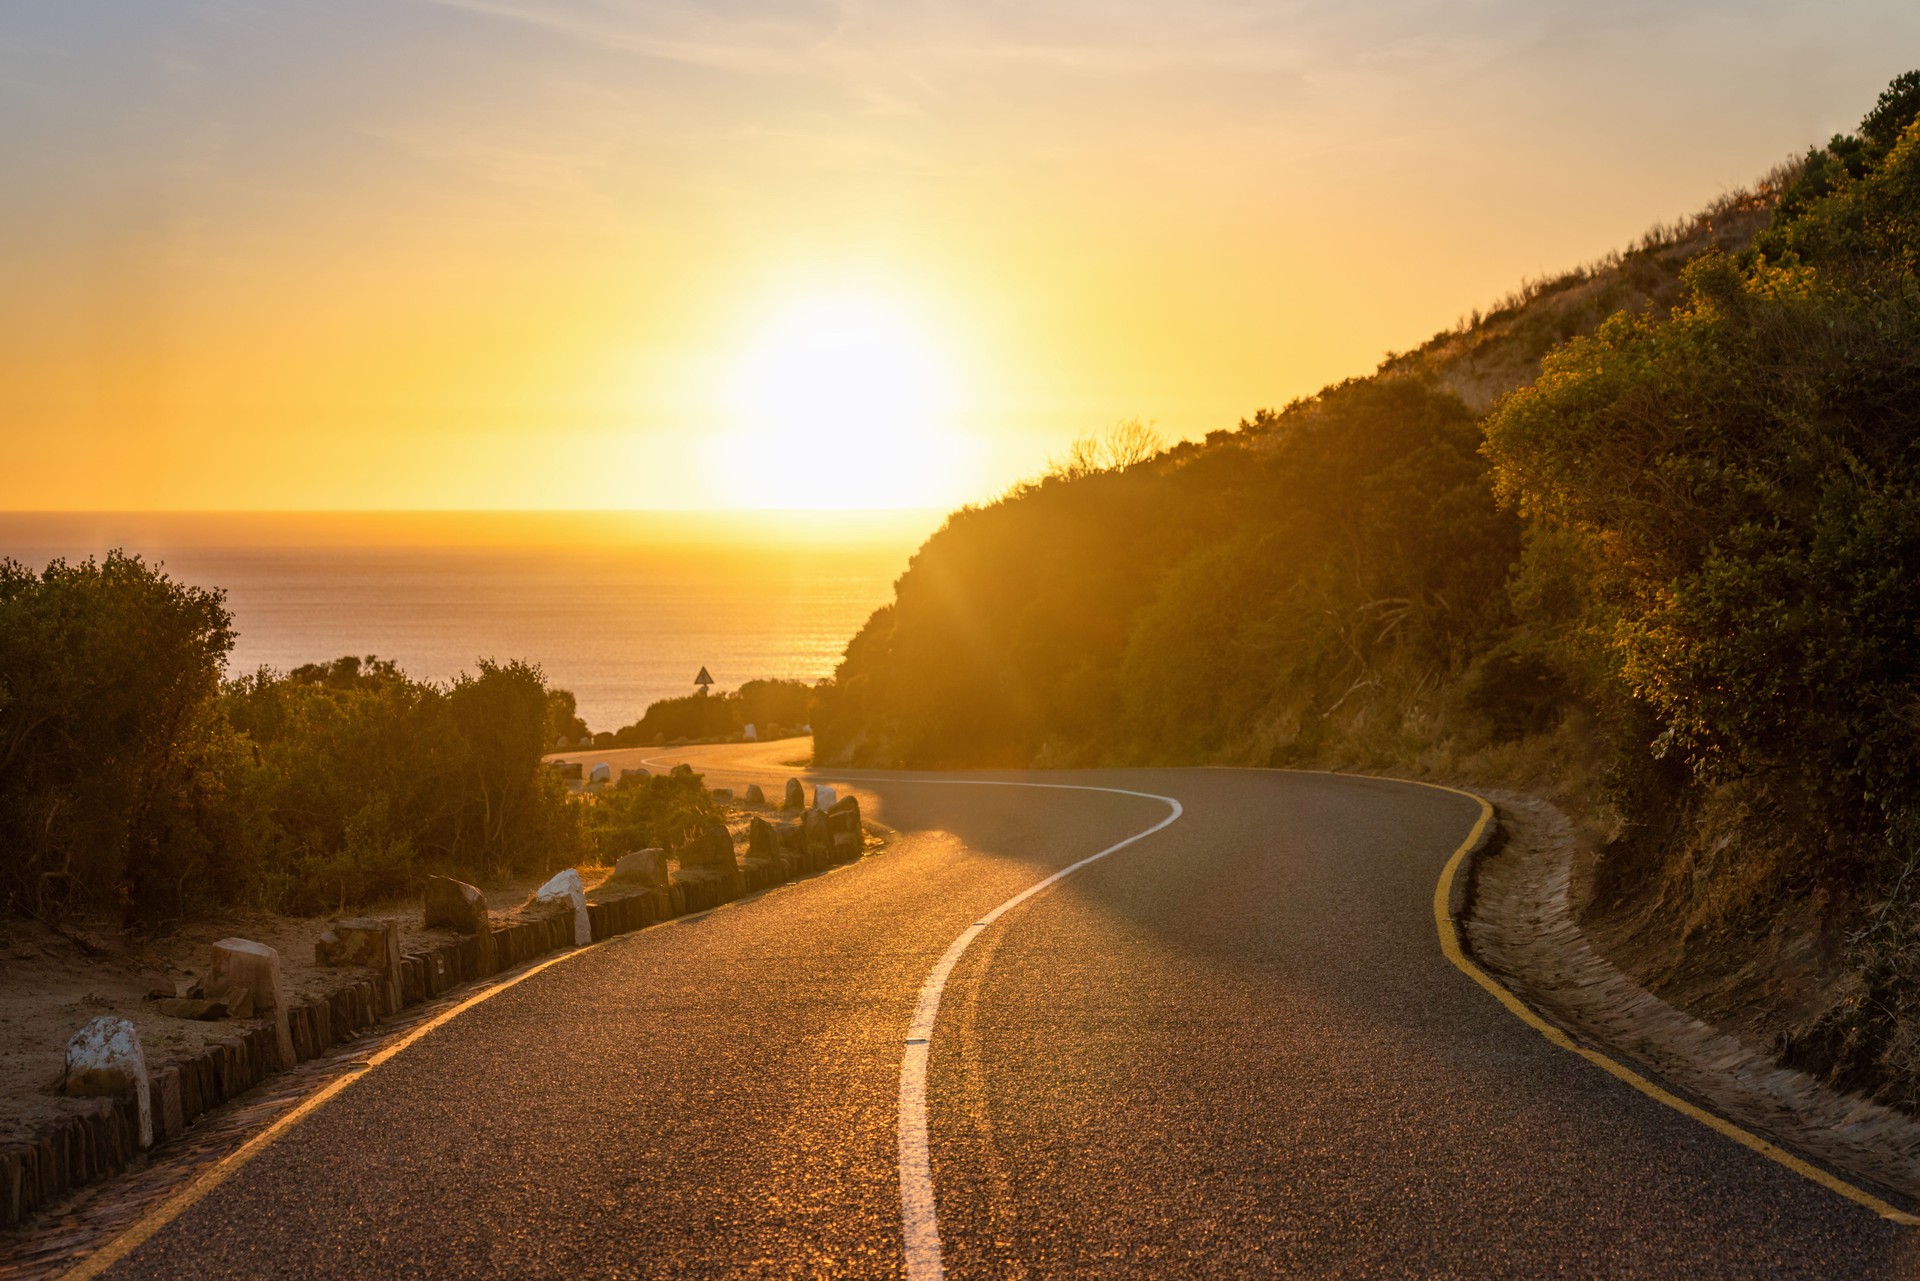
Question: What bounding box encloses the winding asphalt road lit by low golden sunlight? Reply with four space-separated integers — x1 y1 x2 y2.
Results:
97 749 1920 1281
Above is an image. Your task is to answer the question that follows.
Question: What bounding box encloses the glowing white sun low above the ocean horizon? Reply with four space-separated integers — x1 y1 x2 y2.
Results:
716 296 966 507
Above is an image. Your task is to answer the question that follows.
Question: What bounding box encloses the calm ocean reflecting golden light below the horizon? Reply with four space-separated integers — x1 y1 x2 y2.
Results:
0 511 941 730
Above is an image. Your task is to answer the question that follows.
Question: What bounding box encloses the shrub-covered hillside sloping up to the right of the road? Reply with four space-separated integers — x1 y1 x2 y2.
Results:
814 73 1920 1106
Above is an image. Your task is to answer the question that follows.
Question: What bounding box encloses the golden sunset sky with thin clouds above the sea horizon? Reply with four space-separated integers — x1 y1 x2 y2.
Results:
0 0 1920 509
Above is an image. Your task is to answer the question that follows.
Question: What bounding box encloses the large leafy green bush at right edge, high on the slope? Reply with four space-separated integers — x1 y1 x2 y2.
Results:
1486 117 1920 826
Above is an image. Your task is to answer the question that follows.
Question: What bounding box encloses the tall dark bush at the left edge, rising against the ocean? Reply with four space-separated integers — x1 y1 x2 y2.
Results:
0 551 240 920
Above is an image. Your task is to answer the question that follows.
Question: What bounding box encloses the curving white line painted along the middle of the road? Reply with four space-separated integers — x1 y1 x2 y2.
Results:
864 776 1185 1281
